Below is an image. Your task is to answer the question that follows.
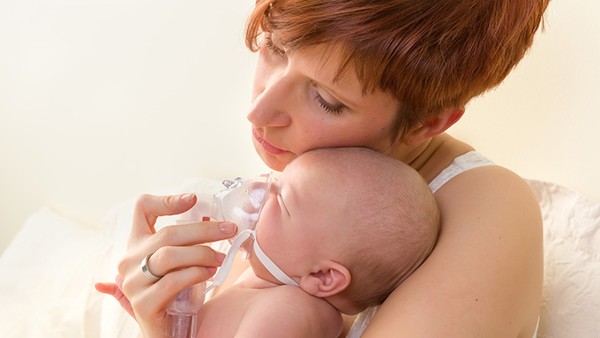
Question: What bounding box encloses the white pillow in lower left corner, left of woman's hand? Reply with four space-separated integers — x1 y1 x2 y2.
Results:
0 208 110 338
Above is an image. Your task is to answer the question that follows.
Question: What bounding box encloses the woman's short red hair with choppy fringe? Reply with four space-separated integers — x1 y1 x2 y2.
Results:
246 0 549 138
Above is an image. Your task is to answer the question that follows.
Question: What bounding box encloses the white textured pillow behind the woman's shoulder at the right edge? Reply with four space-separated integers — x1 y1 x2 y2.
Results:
530 180 600 338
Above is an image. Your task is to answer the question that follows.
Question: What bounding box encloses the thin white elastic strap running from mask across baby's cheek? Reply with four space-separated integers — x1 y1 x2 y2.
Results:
204 229 299 293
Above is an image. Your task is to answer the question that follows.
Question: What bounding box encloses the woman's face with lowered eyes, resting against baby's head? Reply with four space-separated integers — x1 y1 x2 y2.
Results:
248 34 398 171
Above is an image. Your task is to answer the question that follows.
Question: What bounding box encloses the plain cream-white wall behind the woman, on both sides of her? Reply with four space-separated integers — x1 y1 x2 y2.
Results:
0 0 600 250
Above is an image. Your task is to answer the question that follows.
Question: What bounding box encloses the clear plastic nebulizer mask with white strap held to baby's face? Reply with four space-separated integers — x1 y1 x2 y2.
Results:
165 174 298 338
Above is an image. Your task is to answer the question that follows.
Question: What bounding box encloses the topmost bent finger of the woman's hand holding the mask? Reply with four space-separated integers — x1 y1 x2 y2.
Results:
129 194 197 243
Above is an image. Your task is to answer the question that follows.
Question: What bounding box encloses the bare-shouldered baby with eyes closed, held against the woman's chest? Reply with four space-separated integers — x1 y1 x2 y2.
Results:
197 148 439 337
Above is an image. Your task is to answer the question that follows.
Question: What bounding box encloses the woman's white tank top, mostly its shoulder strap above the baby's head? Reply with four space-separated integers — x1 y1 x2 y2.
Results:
346 151 539 338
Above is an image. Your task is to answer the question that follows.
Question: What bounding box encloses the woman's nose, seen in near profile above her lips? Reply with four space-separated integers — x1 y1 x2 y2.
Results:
247 74 294 127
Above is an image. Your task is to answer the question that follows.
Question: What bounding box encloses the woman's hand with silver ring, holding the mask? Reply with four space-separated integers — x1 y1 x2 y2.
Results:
102 194 236 338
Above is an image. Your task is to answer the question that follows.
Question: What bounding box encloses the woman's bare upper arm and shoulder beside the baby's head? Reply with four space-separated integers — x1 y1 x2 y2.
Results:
363 167 543 338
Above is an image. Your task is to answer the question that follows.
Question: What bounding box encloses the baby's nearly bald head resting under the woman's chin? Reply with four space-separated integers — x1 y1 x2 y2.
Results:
246 148 439 313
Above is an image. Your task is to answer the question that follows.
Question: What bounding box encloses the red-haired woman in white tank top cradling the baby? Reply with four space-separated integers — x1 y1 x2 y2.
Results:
105 0 548 337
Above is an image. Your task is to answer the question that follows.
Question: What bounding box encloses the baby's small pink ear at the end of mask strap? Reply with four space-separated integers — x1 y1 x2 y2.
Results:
300 260 350 298
